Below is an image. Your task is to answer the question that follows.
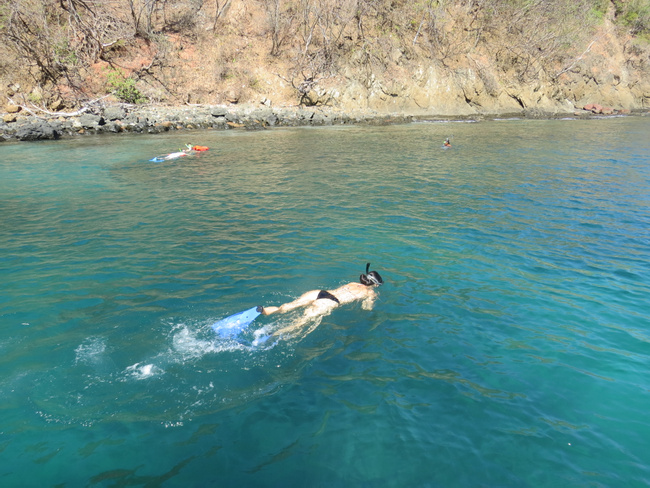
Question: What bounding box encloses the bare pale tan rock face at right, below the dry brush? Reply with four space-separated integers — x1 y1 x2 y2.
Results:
314 18 650 115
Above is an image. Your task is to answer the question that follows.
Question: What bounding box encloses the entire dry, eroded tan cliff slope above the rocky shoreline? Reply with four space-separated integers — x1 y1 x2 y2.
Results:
0 0 650 119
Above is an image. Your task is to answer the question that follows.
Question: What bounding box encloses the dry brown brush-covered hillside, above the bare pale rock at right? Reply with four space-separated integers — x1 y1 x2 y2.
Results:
0 0 650 111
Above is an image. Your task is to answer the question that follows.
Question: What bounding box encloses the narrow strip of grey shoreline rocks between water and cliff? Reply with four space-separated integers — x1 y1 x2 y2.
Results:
0 104 644 142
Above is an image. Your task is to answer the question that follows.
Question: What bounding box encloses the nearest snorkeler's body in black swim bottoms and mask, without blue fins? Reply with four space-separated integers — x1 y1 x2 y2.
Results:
257 263 384 336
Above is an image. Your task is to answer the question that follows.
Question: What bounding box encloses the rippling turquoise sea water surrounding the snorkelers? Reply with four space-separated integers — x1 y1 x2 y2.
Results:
0 117 650 487
